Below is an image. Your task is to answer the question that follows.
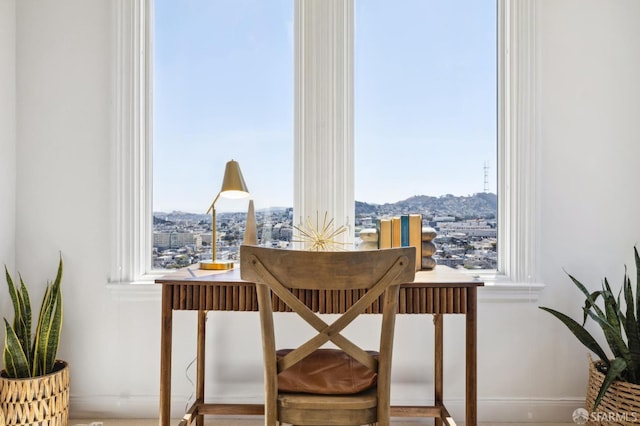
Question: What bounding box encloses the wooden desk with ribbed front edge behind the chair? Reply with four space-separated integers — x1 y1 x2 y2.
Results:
156 266 483 426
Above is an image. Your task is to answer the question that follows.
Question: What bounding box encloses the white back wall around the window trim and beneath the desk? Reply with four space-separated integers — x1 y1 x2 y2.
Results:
8 0 640 422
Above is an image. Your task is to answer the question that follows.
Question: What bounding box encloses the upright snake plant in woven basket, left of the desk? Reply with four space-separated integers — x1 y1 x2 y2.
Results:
0 257 69 426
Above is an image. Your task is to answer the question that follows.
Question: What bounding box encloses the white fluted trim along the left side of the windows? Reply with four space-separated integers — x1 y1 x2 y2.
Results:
109 0 162 284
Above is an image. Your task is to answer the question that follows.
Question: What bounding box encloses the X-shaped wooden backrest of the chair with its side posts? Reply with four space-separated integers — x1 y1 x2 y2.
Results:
240 246 415 424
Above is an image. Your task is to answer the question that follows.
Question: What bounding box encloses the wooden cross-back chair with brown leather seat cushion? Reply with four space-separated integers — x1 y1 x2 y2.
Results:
240 246 415 426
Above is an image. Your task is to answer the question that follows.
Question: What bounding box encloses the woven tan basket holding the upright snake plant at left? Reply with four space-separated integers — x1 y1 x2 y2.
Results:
0 361 69 426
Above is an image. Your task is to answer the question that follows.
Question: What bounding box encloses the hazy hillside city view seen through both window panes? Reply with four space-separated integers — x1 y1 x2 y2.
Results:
153 193 497 269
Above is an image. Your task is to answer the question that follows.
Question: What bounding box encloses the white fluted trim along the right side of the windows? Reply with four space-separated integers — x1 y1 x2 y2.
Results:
490 0 544 301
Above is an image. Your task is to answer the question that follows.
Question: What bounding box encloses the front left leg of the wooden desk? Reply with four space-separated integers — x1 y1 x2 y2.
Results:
158 284 173 426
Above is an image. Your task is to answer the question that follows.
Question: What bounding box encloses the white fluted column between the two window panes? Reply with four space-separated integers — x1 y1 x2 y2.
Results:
294 0 355 246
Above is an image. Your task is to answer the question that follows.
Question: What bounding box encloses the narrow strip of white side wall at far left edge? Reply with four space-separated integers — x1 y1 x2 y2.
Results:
0 0 16 271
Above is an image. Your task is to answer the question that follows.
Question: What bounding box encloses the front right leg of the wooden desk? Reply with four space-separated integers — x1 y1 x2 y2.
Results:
465 287 478 426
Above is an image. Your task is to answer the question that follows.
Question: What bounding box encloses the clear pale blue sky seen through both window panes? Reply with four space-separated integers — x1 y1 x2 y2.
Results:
153 0 496 212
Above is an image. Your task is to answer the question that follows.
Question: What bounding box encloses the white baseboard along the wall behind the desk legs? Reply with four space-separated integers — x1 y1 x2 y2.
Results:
70 395 584 423
